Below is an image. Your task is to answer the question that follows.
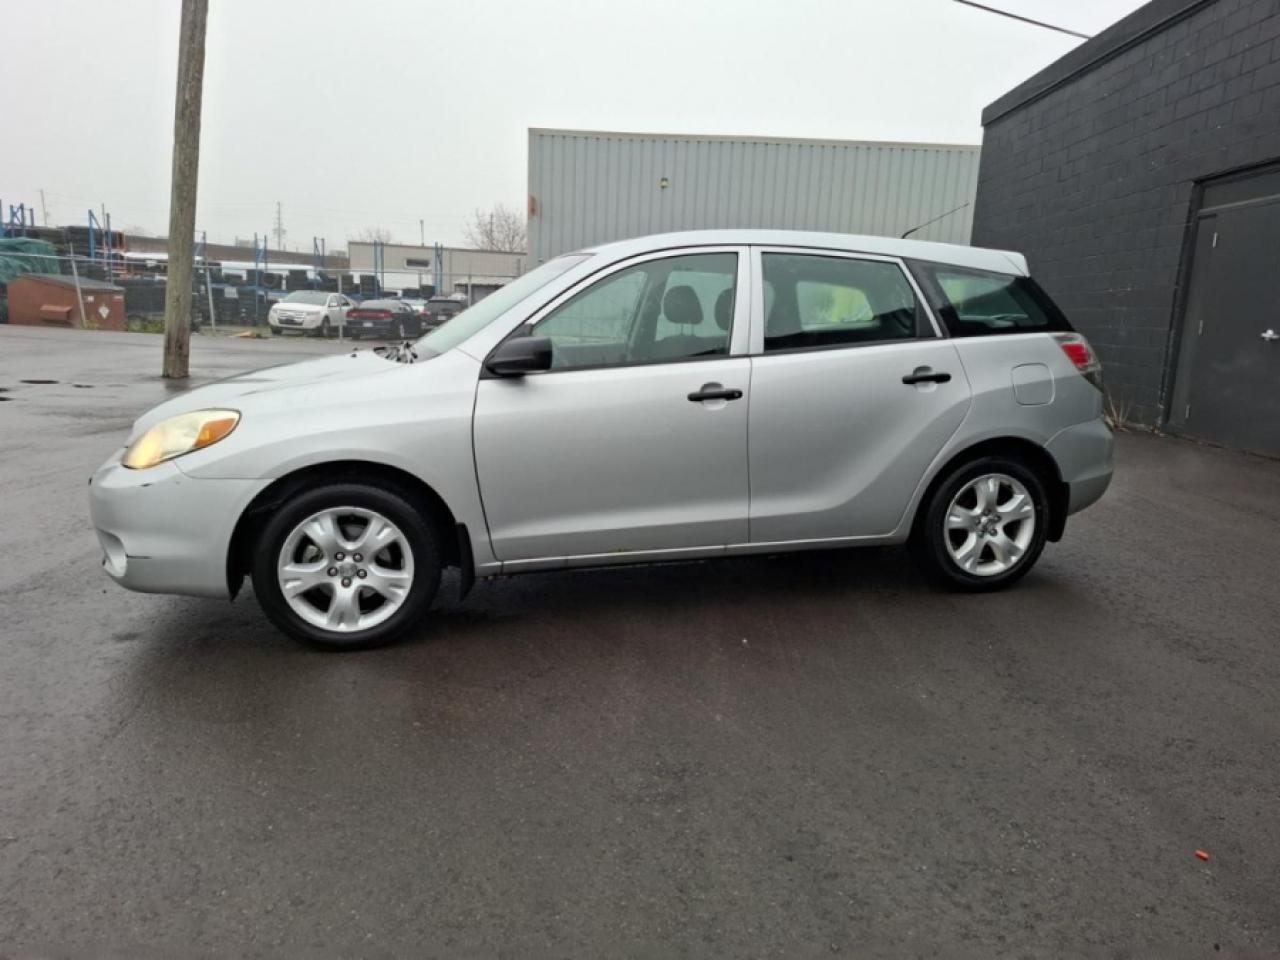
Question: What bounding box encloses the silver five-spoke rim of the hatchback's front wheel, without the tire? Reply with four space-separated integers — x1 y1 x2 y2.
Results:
276 507 413 634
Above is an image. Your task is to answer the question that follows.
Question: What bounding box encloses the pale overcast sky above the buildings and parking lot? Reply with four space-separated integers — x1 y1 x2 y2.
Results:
0 0 1140 251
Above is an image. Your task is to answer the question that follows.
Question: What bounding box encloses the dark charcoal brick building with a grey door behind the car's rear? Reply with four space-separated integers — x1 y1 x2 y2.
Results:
973 0 1280 457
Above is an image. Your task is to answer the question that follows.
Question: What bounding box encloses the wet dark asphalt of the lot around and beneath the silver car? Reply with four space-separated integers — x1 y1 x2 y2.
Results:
0 326 1280 956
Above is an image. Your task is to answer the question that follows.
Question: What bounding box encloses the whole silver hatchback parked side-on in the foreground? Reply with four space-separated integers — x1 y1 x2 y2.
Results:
90 230 1112 649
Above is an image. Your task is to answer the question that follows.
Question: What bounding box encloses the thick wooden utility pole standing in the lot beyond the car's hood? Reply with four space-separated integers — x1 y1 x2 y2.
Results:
164 0 209 378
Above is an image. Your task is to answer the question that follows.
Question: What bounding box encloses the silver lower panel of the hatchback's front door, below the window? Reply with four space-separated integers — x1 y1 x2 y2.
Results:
475 357 750 561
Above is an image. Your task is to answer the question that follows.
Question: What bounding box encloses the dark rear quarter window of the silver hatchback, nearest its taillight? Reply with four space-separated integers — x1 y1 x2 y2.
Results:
910 261 1071 337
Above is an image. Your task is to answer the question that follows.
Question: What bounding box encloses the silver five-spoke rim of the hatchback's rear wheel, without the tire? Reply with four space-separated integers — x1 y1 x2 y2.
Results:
943 474 1036 577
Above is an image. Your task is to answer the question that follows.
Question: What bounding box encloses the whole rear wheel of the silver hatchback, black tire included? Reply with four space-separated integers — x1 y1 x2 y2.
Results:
911 456 1050 591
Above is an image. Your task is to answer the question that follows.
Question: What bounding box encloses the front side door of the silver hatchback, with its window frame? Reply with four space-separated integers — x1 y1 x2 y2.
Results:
474 247 751 562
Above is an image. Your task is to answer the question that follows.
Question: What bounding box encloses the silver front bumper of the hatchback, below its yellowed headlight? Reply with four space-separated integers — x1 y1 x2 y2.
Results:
88 453 270 598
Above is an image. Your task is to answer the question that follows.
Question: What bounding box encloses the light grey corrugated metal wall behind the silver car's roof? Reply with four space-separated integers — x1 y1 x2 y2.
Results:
529 129 980 262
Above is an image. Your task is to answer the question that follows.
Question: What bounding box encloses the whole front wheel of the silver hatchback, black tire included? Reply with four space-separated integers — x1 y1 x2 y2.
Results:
252 481 442 650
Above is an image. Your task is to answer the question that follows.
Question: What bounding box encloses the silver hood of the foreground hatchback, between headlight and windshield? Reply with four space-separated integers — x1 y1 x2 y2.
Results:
131 349 394 440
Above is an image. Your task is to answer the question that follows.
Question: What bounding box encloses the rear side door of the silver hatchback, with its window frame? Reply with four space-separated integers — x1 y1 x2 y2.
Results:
748 248 970 543
